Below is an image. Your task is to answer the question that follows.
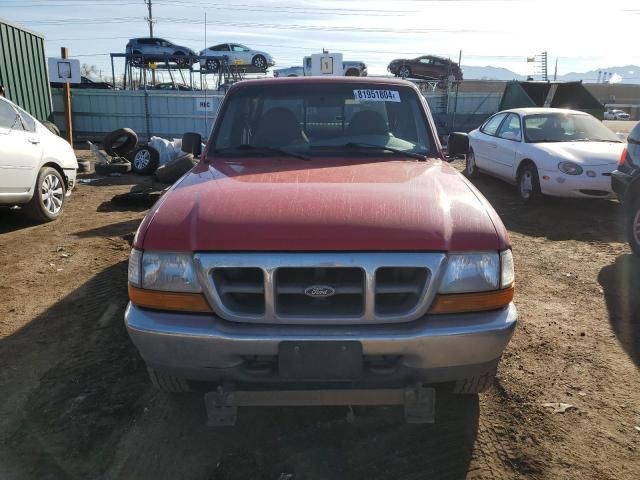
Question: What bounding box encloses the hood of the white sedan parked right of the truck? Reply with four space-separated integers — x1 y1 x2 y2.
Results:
535 142 624 167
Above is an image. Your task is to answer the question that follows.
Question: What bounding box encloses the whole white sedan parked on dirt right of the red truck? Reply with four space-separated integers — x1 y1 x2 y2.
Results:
465 108 624 203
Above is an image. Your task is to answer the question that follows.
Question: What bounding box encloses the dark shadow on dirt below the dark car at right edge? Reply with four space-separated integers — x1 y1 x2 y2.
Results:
598 255 640 367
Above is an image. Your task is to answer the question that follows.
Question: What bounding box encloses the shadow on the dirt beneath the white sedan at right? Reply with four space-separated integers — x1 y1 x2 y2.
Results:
464 169 626 243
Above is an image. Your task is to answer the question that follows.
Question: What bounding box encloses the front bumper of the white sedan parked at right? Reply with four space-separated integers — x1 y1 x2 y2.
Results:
540 165 615 198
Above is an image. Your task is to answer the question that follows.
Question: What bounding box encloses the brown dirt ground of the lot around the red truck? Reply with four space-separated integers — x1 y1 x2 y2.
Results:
0 147 640 480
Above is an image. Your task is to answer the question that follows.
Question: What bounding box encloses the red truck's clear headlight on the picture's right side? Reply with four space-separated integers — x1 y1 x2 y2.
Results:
439 252 500 293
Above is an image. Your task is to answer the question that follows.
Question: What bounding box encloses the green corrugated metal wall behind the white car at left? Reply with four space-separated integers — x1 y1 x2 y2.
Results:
0 18 52 120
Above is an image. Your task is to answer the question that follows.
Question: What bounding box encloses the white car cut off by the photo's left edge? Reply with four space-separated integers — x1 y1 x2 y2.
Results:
0 97 78 222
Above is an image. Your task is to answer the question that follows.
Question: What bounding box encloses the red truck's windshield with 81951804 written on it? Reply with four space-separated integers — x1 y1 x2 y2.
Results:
212 83 435 158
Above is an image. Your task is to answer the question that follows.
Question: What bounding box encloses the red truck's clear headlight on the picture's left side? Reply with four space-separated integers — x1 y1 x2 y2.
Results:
140 252 201 292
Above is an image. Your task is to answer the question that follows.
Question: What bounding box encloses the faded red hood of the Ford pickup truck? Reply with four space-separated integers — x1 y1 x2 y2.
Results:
134 157 509 251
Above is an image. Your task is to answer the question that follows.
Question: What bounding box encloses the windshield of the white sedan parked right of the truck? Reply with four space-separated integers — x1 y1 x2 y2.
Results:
524 113 620 143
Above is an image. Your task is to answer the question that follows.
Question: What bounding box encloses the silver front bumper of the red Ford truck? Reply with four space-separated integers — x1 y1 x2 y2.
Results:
125 303 517 384
